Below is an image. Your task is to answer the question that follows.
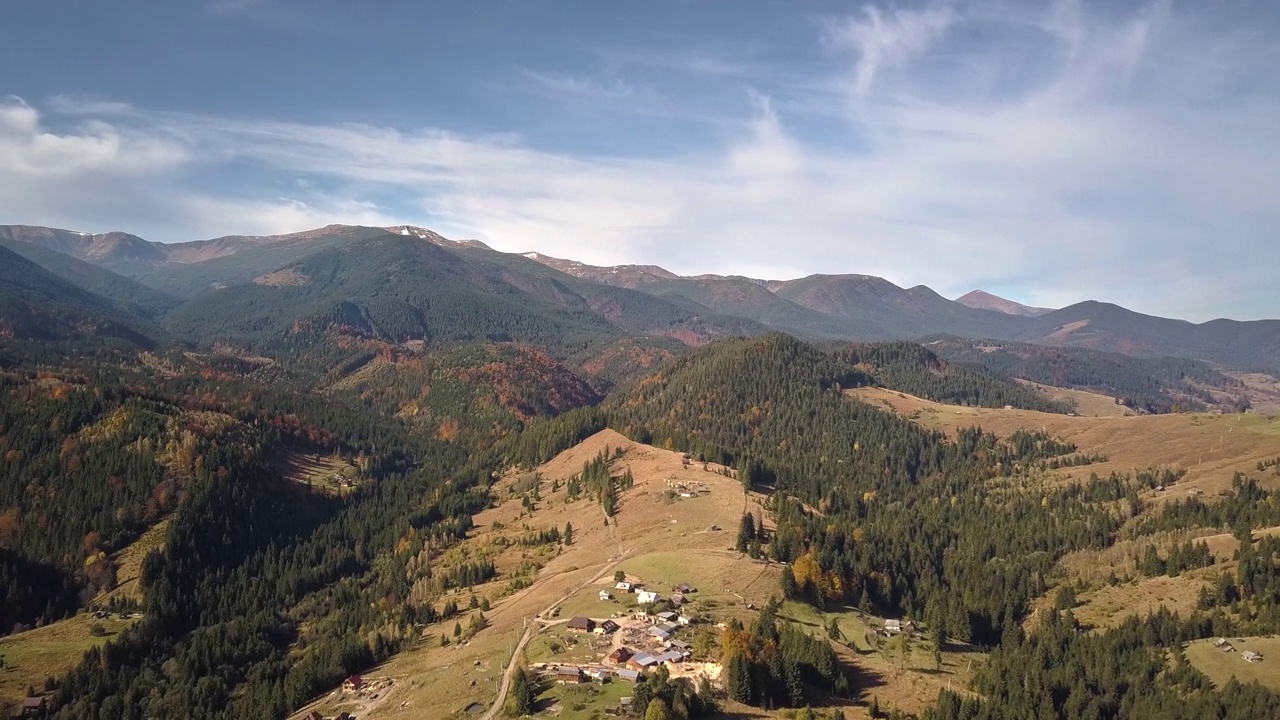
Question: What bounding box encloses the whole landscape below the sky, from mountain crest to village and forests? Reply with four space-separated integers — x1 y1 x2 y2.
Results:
0 225 1280 720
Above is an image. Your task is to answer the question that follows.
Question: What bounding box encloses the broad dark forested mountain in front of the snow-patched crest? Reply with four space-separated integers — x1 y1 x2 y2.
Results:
168 232 622 355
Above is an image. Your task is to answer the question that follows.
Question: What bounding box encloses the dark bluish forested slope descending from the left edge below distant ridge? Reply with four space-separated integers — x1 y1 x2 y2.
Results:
0 247 159 347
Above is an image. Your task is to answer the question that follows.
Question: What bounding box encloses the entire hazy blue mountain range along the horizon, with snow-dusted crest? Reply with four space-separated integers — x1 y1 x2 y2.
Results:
0 225 1280 372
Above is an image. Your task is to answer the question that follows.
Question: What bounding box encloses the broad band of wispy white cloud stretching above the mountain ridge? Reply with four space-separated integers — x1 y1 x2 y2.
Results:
0 3 1280 319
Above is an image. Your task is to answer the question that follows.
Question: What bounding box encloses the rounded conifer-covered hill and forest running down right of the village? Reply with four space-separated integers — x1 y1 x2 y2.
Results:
607 337 1280 720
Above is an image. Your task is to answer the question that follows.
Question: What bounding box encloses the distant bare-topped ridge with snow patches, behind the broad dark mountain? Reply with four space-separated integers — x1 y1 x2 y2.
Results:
12 220 1280 373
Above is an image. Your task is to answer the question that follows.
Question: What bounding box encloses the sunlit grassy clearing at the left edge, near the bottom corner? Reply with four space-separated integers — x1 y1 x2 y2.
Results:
0 612 137 706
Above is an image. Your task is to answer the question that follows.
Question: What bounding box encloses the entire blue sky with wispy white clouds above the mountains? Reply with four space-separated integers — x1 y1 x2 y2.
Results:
0 0 1280 322
